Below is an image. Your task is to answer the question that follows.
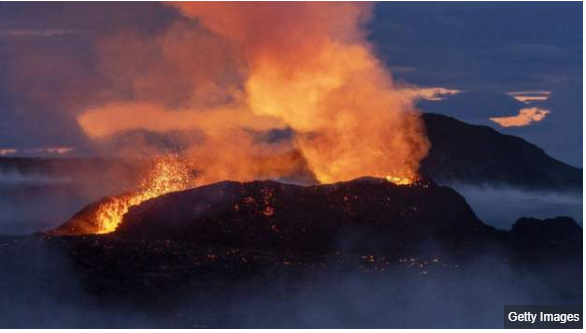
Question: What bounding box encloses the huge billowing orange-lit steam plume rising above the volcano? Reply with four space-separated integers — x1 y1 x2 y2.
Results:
78 2 429 183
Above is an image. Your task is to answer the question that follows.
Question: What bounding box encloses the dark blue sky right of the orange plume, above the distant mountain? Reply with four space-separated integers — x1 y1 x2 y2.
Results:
371 2 582 166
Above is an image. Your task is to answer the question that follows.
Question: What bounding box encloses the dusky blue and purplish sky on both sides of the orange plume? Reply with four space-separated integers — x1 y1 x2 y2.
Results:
0 2 583 167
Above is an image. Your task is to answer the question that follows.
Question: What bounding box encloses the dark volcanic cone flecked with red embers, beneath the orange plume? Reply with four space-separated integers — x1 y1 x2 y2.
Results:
49 177 581 255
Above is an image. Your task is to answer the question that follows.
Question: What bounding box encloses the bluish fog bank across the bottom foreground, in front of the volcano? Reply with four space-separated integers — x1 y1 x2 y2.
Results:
0 239 581 328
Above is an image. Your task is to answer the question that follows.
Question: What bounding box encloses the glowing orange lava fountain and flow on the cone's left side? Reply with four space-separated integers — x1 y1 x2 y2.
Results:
96 156 195 234
